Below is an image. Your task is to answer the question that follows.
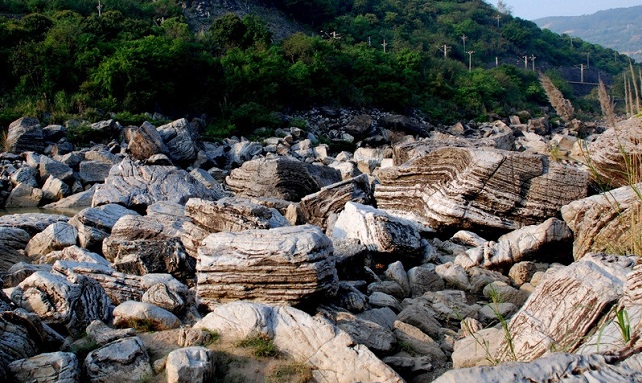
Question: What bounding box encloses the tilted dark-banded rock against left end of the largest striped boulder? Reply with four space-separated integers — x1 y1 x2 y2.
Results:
299 174 371 234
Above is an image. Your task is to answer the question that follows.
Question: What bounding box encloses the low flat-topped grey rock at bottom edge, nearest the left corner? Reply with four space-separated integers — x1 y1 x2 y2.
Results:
7 352 81 383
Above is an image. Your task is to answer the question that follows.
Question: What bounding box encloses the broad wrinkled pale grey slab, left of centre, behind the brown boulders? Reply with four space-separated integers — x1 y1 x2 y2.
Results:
92 160 214 210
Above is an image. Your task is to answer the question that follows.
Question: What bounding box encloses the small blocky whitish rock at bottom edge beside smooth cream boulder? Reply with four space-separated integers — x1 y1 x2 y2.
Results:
165 347 215 383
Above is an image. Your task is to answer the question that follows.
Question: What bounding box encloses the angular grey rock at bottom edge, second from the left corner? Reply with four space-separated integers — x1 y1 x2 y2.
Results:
84 337 153 383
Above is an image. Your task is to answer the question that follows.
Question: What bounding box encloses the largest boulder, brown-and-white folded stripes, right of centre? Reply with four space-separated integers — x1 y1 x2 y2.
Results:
375 147 589 232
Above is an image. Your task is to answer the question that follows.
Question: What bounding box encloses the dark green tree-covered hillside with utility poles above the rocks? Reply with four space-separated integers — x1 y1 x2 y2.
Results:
0 0 629 133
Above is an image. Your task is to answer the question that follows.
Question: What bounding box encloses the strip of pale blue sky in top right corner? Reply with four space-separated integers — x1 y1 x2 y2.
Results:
500 0 642 20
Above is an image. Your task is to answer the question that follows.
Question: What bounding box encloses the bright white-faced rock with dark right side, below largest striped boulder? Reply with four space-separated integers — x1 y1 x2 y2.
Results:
332 202 422 257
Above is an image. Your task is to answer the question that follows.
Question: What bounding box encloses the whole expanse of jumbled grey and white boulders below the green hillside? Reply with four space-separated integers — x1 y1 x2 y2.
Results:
0 108 642 383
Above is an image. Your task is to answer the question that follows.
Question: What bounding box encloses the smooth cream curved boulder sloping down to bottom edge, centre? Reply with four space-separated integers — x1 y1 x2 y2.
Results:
195 302 403 383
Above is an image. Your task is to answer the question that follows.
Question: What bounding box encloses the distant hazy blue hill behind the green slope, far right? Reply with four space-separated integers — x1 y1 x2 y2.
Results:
535 5 642 62
